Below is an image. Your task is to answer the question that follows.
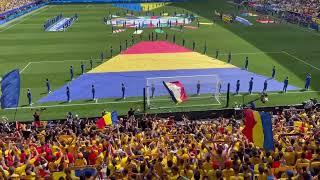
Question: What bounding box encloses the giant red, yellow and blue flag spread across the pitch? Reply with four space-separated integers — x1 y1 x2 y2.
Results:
38 41 298 103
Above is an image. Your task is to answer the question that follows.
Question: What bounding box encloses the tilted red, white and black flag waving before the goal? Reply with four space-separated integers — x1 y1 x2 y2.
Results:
163 81 188 103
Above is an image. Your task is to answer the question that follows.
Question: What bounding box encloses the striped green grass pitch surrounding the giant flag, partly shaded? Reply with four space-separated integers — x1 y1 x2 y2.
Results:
0 0 320 121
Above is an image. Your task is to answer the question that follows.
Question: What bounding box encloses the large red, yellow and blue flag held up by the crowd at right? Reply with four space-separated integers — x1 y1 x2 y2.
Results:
242 109 274 150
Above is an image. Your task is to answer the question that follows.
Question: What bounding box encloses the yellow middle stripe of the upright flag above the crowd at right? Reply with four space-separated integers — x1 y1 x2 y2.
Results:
252 111 264 148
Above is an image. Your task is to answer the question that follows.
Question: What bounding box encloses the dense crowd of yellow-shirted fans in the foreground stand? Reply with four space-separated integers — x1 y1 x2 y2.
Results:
0 106 320 180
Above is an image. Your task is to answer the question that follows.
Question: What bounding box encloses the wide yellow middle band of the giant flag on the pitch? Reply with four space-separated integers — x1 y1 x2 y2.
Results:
89 52 235 73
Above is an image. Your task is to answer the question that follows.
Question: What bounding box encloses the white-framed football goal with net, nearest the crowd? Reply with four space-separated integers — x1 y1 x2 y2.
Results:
146 75 222 109
